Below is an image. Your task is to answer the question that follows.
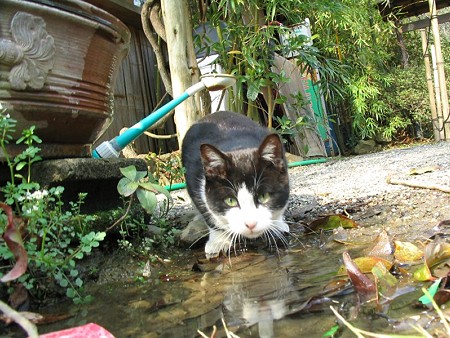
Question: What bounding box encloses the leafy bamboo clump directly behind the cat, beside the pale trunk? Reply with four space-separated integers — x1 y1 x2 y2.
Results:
194 0 345 128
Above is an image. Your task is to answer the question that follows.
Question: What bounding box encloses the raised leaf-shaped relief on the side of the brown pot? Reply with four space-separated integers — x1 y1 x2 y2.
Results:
0 12 55 90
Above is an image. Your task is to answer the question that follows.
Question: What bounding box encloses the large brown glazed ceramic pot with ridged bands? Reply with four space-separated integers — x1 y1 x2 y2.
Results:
0 0 130 158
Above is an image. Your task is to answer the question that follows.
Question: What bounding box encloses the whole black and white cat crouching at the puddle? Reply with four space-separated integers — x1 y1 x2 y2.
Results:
182 111 289 258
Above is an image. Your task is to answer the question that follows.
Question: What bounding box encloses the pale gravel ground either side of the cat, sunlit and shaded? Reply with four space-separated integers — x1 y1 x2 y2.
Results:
171 142 450 240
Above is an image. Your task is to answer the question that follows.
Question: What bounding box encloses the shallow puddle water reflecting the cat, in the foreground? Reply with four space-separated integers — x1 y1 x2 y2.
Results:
29 232 434 338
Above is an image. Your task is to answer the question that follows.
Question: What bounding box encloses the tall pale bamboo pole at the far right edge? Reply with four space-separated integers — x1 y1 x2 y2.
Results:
428 0 450 140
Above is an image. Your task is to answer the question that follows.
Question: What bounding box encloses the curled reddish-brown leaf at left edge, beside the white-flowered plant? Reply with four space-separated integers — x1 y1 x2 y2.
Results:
0 202 28 283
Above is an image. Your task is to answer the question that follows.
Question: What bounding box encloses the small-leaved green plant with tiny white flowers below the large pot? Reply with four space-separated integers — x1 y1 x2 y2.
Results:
0 110 106 303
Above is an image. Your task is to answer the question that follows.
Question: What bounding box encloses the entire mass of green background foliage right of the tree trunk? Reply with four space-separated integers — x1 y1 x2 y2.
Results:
189 0 442 151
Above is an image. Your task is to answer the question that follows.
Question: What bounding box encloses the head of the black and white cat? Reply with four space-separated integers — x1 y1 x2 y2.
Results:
200 134 289 238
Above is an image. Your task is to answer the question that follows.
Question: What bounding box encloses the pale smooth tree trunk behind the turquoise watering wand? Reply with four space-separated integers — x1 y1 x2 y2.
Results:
161 0 202 148
